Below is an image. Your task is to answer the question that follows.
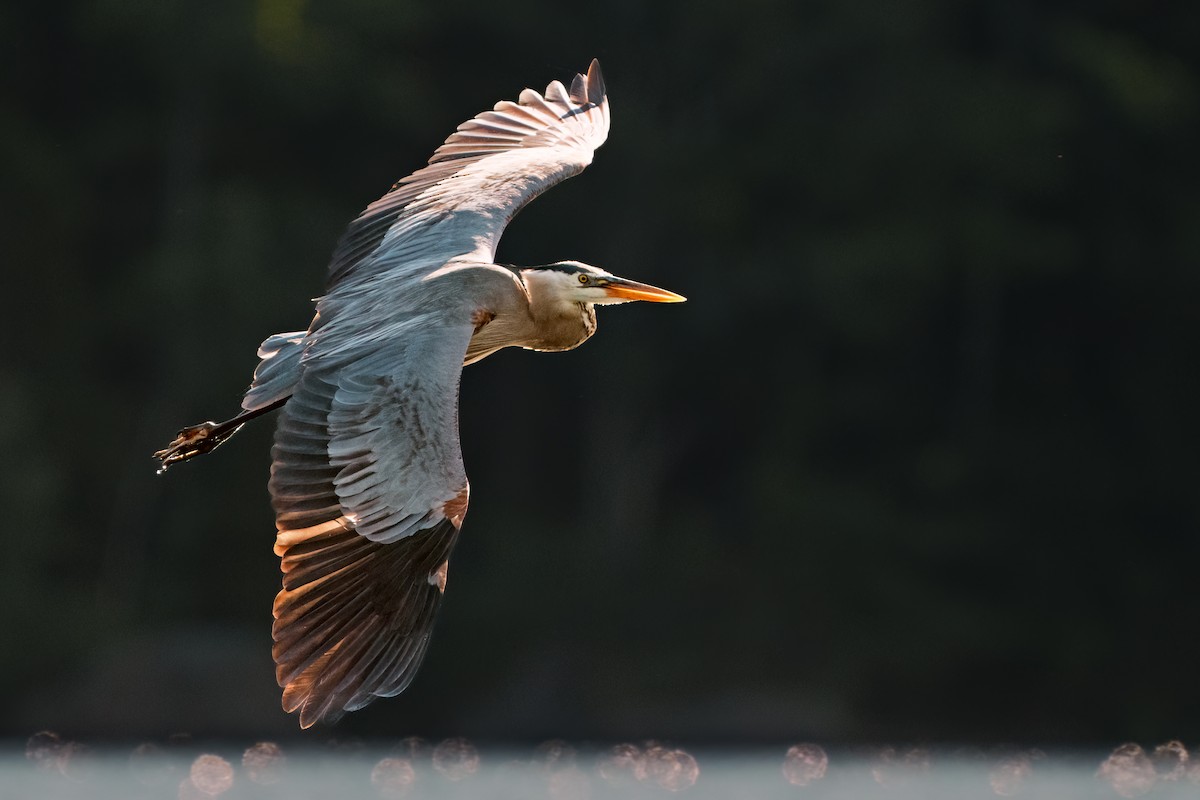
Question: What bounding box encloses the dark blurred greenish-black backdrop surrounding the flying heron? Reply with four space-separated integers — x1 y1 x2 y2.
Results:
0 0 1200 746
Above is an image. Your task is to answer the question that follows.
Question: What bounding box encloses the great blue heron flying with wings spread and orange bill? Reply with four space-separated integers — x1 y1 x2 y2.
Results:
155 61 684 728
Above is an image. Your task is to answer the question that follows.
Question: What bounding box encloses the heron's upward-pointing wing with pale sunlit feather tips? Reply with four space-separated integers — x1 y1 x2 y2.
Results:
329 60 608 288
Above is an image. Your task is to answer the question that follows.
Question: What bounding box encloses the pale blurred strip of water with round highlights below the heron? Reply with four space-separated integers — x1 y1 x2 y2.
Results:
11 730 1200 800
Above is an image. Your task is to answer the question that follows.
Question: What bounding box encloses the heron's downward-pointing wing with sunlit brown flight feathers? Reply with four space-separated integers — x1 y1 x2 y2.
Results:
270 319 473 728
